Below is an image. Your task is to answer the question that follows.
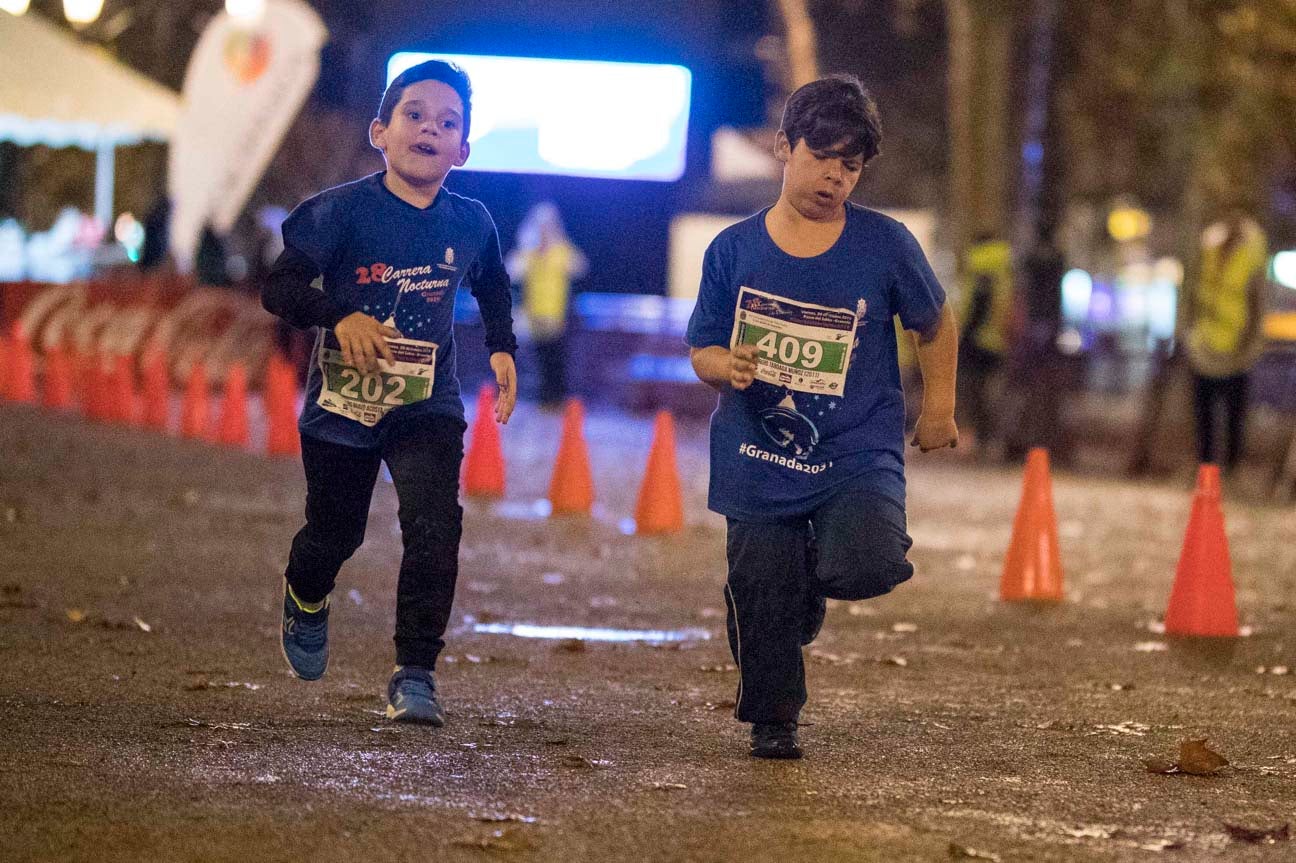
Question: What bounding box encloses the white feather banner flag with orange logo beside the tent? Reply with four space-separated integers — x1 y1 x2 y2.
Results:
167 0 328 272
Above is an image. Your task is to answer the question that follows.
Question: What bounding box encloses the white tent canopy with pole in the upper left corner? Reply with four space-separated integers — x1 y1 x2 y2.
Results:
0 12 180 225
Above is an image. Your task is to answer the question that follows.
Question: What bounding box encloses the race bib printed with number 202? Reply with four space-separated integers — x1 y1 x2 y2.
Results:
316 330 437 425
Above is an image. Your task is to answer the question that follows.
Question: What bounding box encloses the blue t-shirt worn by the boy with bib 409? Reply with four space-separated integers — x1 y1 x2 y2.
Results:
688 203 945 522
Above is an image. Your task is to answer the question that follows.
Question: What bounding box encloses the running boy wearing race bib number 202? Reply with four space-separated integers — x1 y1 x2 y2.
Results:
262 61 517 726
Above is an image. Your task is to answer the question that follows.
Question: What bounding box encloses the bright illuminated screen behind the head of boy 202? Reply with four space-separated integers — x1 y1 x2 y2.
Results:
388 52 693 181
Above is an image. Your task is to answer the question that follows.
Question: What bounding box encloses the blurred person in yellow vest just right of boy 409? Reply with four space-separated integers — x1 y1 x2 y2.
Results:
958 235 1013 455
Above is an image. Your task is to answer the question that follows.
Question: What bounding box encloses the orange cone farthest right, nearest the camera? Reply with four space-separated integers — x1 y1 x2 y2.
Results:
1165 464 1238 638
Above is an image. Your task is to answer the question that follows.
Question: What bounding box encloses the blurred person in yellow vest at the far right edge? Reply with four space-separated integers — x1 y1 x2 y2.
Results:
1185 209 1269 472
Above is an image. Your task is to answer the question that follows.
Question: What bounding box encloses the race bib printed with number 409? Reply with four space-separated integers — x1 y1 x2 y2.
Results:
730 288 863 395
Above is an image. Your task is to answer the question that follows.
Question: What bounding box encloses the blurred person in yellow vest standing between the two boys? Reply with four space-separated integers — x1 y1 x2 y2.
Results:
507 201 588 407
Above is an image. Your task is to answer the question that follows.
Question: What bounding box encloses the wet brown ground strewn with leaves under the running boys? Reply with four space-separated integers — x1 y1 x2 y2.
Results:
0 406 1296 863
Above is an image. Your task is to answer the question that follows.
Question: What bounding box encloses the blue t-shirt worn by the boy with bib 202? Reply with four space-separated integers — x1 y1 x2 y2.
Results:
284 172 509 447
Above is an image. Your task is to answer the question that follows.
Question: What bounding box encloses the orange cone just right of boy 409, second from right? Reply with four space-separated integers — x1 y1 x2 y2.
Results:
999 447 1063 603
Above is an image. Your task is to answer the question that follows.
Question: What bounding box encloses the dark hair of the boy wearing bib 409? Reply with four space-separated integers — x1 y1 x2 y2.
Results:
780 75 883 165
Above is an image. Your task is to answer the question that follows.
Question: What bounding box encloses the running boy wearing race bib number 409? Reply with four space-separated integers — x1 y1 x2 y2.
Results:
688 75 958 758
